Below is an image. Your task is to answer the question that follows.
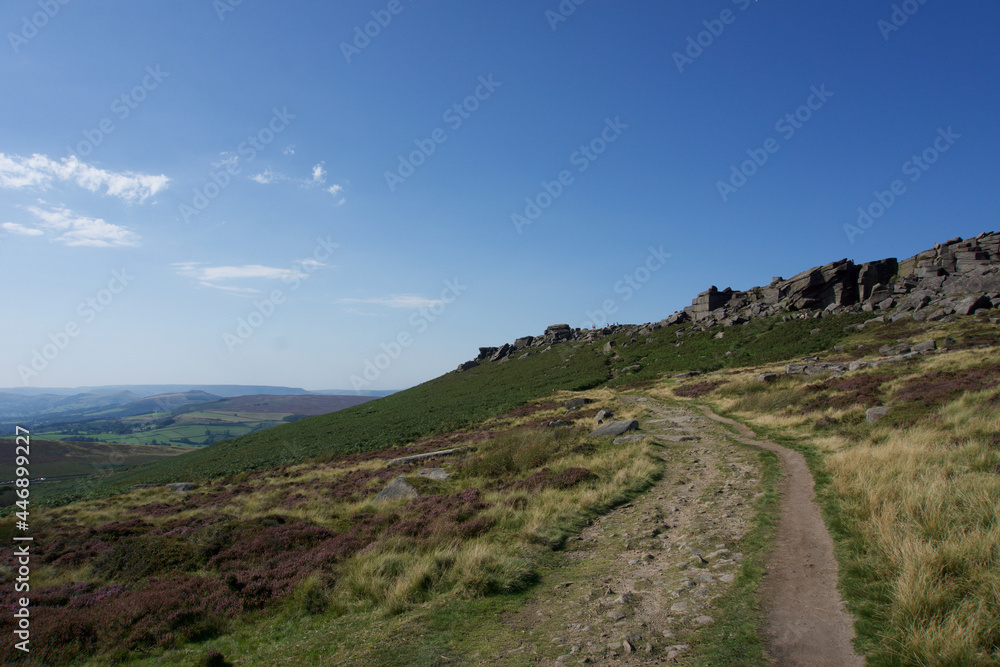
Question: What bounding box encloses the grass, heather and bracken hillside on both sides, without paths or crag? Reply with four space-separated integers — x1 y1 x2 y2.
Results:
9 306 1000 666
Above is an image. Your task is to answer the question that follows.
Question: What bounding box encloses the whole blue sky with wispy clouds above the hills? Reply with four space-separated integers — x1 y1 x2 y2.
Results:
0 0 1000 389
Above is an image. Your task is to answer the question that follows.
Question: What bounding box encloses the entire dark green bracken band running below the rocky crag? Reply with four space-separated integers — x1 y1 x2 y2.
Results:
56 315 884 506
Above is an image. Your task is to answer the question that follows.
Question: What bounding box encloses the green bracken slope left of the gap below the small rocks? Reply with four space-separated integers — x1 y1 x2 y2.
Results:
52 345 609 500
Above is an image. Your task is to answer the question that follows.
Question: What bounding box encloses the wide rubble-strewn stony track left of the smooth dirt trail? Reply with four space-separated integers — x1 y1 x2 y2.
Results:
490 398 761 665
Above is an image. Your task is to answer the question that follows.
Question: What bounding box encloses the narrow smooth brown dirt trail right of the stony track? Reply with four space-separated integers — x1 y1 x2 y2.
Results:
699 406 864 667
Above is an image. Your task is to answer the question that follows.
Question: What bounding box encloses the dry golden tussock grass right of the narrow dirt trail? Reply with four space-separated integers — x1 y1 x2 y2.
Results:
664 342 1000 665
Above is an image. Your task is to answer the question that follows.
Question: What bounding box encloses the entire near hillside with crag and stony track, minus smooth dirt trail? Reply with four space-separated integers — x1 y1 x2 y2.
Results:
0 231 1000 665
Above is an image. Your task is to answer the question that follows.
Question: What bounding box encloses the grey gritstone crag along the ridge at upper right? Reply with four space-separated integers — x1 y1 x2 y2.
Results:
460 232 1000 373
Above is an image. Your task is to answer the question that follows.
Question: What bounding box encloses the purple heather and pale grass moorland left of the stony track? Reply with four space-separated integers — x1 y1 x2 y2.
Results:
0 396 662 665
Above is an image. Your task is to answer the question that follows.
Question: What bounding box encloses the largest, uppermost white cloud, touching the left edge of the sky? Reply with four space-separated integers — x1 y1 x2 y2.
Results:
0 153 170 204
